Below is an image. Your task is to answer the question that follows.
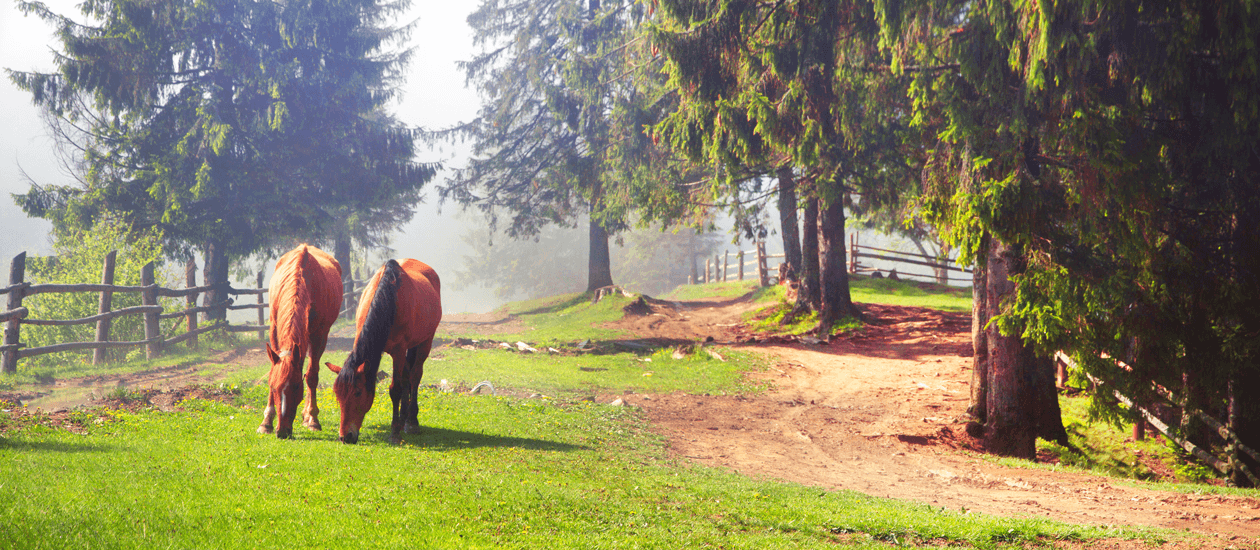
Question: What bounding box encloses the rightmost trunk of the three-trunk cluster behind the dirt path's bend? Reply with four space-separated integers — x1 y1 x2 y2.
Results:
818 196 862 339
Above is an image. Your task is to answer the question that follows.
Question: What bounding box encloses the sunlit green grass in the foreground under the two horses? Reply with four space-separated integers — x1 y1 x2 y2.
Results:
0 386 1114 549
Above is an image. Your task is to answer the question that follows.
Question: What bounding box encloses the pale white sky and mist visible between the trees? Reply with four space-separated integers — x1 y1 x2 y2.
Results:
0 0 927 312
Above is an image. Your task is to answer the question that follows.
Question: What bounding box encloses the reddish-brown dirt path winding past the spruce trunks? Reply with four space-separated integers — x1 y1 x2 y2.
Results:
599 295 1260 547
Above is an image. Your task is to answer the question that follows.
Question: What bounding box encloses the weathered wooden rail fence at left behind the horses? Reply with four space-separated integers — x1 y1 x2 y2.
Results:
0 252 364 374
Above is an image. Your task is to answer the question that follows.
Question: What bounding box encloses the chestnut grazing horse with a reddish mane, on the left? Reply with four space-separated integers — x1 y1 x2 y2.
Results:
258 244 341 439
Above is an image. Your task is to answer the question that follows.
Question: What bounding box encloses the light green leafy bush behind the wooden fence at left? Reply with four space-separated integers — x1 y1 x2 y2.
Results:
21 218 179 366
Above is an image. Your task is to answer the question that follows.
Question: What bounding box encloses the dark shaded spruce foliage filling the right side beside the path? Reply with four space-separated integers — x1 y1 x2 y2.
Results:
879 1 1260 470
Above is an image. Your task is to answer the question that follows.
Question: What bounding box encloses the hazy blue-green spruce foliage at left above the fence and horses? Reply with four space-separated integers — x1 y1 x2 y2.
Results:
9 0 435 263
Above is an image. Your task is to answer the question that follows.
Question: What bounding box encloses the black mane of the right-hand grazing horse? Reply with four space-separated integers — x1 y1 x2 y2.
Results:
336 259 402 393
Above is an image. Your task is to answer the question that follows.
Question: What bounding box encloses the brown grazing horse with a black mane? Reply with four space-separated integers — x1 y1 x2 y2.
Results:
328 259 442 443
